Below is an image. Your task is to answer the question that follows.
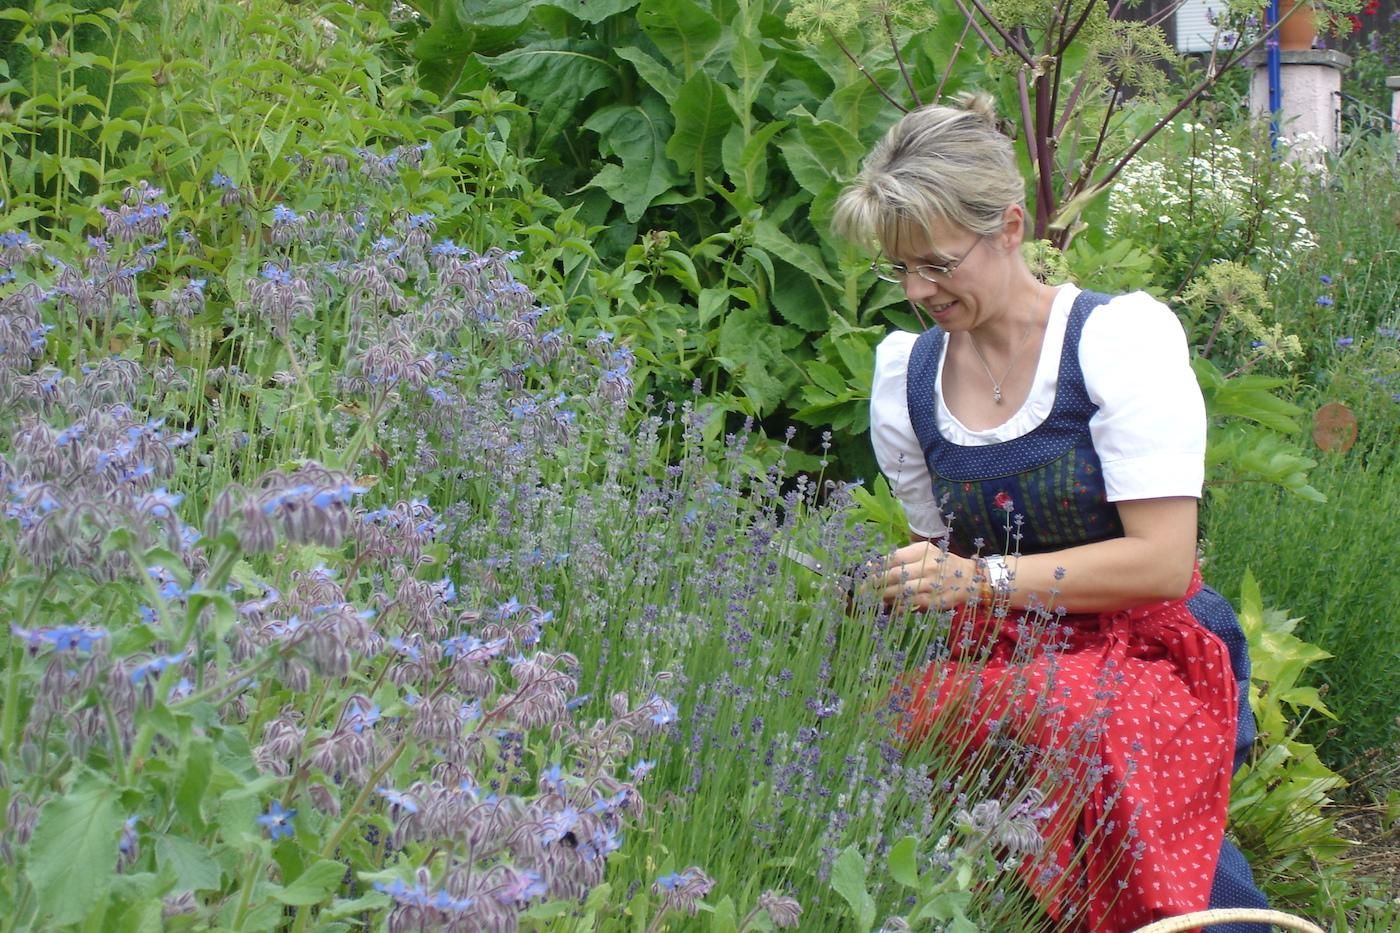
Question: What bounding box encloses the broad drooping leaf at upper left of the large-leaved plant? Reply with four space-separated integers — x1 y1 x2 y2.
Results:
483 39 617 151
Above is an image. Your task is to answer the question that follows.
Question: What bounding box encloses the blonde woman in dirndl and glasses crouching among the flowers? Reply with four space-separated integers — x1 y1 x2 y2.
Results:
836 98 1264 933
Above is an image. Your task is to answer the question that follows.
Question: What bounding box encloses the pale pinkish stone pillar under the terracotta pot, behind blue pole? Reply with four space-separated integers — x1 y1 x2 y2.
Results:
1246 49 1351 163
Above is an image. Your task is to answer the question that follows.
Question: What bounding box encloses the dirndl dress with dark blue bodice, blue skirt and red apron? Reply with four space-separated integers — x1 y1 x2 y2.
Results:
906 291 1267 933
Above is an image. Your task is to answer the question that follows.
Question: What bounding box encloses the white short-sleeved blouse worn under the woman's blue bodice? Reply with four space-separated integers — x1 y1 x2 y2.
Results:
871 284 1205 538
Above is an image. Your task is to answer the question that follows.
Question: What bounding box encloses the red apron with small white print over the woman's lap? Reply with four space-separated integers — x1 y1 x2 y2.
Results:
907 574 1238 933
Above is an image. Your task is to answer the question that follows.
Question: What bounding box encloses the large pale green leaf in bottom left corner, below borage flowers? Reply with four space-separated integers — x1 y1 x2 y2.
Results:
28 783 123 926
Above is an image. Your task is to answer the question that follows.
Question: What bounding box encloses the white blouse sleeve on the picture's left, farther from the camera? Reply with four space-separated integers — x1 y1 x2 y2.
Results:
871 331 948 538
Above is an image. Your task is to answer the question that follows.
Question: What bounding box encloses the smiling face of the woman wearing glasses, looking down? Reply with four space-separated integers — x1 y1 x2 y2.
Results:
890 210 1012 332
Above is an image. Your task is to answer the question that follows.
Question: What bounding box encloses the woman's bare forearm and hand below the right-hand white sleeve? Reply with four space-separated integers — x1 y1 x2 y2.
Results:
874 496 1197 612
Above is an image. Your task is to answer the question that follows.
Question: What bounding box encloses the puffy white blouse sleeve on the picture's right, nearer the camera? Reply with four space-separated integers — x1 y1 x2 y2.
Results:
1079 291 1205 502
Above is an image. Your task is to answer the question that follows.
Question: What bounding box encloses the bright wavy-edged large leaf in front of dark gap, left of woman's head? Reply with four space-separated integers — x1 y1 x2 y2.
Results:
584 94 682 223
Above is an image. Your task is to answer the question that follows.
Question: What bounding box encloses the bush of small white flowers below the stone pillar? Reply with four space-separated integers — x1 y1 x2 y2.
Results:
1107 122 1317 277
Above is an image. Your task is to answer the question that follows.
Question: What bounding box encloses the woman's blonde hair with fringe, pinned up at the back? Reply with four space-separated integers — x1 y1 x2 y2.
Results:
832 94 1026 251
